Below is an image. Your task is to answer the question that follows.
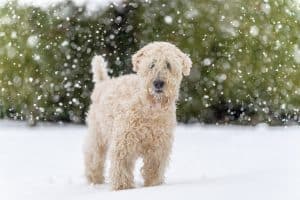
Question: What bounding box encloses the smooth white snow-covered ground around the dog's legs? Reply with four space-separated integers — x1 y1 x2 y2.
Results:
0 121 300 200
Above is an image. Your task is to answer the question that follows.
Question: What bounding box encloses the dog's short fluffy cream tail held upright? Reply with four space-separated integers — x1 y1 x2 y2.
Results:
91 56 109 83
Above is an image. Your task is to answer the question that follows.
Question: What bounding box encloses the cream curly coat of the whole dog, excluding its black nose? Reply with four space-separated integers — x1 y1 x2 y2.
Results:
84 42 192 190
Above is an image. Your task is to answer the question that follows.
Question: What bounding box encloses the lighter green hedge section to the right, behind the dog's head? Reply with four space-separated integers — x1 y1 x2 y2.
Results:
123 0 300 124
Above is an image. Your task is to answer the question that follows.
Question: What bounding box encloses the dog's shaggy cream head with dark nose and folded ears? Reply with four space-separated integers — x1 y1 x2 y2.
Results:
132 42 192 107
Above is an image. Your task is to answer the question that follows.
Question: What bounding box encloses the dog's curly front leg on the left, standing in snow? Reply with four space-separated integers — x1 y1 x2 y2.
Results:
110 140 135 190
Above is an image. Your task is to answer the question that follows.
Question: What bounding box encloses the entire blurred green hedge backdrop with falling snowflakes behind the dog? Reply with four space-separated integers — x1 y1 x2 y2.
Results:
0 0 300 125
